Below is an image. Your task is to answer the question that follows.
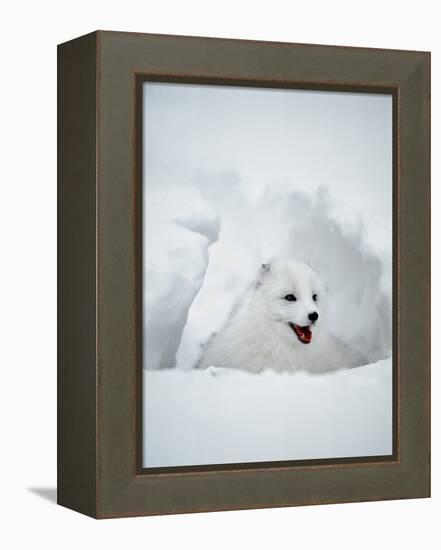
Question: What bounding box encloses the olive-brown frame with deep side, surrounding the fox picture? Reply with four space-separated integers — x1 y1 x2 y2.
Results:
58 31 430 518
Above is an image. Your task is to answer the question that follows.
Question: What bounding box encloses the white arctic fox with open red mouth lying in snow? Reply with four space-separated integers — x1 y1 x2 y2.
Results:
198 260 365 373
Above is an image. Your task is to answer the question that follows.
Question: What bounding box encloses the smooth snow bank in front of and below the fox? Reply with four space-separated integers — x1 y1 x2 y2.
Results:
144 359 392 467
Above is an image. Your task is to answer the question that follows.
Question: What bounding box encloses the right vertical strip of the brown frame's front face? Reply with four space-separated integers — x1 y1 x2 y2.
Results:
398 54 431 497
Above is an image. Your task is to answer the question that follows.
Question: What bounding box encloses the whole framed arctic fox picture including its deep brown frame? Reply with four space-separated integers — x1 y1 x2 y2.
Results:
58 31 430 518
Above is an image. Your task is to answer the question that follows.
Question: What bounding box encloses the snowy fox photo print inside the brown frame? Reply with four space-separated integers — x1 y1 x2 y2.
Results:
142 82 393 468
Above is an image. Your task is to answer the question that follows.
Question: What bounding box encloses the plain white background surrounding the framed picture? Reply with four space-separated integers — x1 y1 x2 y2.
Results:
0 0 441 549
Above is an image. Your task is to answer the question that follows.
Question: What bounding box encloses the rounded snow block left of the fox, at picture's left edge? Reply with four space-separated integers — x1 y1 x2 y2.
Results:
143 186 219 369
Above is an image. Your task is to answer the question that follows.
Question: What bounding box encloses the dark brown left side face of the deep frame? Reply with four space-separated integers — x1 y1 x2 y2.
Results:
57 33 97 517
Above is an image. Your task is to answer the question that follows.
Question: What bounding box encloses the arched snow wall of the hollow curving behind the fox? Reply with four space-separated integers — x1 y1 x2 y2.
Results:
177 184 392 369
